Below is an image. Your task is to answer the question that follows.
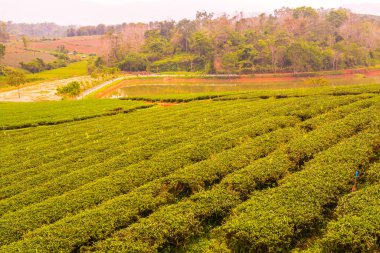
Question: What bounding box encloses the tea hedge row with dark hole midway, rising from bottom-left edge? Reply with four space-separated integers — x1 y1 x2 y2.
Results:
1 121 300 251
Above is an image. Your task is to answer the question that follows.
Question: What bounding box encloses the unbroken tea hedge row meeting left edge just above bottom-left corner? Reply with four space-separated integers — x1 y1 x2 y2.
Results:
0 114 300 244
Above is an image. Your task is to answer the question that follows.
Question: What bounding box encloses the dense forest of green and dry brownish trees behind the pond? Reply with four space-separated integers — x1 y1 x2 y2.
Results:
93 7 380 74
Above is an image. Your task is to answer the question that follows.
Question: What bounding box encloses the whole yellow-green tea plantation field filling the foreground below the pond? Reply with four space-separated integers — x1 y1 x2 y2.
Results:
0 85 380 253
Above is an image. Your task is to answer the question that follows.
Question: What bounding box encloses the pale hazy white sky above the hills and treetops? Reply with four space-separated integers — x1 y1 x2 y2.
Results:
0 0 380 25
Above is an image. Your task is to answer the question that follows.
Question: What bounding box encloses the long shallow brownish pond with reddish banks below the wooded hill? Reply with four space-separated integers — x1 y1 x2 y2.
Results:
102 76 380 98
